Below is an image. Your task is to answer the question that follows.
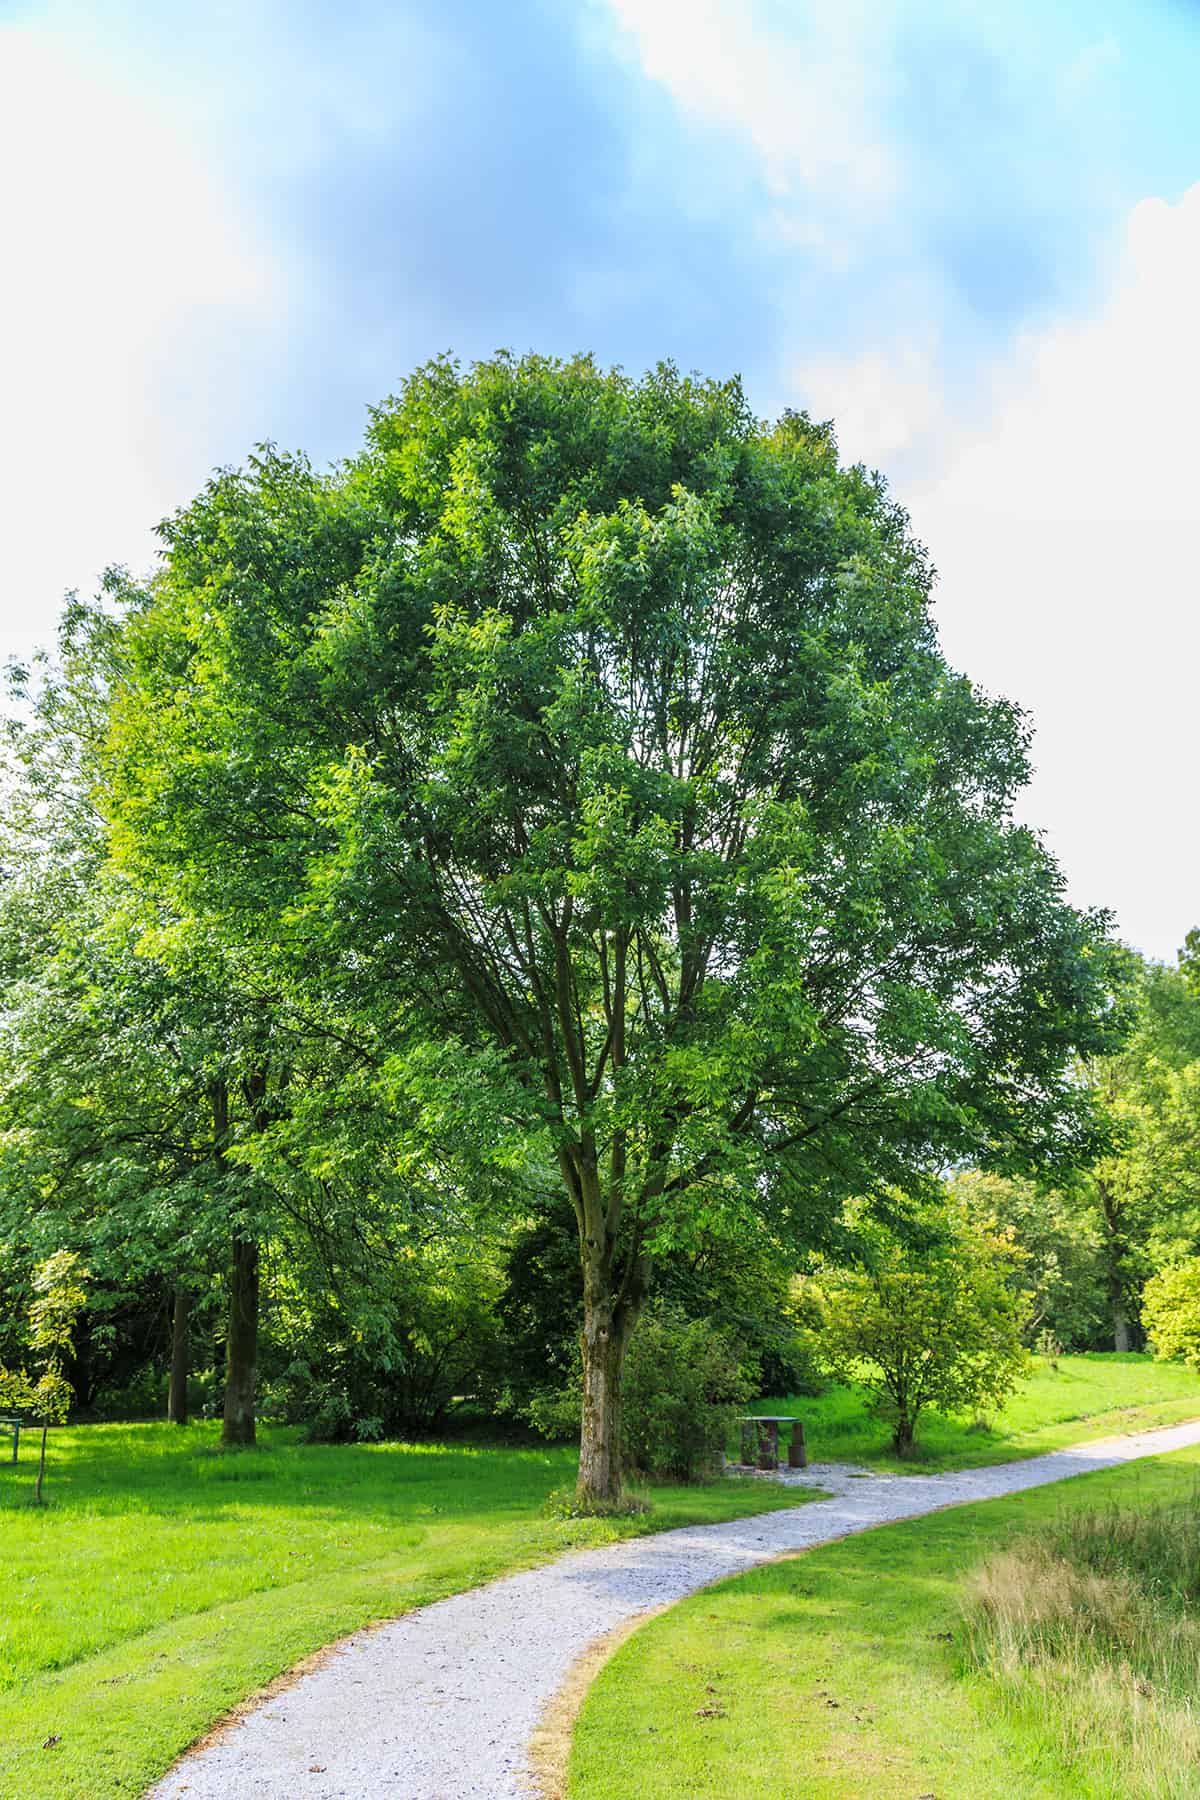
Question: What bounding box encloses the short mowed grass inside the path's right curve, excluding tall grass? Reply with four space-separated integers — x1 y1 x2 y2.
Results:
567 1449 1200 1800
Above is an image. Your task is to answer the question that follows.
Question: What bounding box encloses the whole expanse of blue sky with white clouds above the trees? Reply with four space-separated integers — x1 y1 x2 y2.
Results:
0 0 1200 956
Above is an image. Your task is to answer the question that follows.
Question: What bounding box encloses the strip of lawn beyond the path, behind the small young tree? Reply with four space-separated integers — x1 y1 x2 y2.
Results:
756 1354 1200 1474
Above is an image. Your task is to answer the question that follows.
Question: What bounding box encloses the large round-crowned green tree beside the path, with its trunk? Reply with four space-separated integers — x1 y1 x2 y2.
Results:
108 356 1108 1501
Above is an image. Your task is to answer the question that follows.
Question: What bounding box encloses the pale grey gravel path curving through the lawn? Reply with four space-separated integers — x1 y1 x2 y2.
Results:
149 1422 1200 1800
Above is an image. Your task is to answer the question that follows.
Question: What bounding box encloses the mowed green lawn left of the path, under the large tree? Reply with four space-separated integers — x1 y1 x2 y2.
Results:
0 1426 797 1800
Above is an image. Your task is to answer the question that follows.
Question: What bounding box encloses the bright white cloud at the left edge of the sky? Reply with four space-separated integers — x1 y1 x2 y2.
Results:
0 27 279 648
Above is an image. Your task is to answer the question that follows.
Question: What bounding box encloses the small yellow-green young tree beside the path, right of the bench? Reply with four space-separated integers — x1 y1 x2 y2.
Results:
811 1208 1027 1456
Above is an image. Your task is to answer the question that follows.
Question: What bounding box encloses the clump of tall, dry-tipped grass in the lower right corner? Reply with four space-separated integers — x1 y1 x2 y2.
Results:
964 1490 1200 1800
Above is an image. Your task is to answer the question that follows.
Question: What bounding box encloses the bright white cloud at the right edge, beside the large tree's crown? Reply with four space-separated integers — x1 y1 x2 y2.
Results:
910 184 1200 956
